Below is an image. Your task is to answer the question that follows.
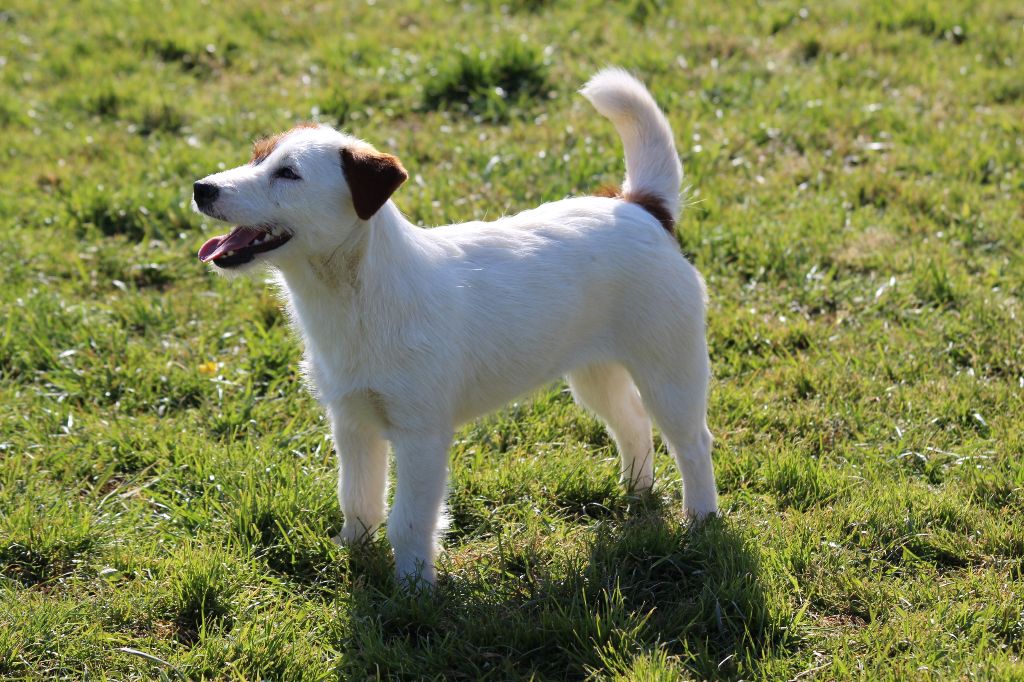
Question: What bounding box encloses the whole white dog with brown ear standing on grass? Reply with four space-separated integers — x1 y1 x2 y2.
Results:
193 69 718 585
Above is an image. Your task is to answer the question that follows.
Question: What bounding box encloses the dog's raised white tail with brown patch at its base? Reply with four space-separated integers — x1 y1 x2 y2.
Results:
580 68 683 231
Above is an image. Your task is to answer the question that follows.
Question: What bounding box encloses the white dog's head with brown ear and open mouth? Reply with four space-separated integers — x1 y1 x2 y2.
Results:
193 124 409 269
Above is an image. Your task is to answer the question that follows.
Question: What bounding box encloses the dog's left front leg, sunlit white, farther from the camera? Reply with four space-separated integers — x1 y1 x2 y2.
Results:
331 411 387 545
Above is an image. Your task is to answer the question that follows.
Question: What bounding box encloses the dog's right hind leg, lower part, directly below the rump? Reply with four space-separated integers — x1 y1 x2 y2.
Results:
634 354 718 517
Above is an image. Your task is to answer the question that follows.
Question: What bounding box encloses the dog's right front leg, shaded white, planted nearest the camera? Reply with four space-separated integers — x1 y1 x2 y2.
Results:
387 429 453 585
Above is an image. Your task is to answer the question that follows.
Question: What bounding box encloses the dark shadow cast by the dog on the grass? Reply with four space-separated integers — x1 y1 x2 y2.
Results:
338 499 784 679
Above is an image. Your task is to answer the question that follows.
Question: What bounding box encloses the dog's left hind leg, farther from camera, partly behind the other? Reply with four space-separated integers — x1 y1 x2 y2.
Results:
568 364 654 493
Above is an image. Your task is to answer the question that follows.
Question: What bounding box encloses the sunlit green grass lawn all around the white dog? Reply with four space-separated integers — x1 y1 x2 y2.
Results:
0 0 1024 680
